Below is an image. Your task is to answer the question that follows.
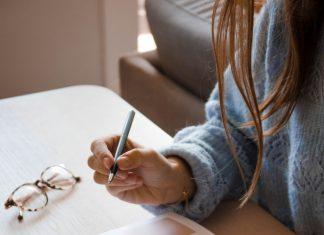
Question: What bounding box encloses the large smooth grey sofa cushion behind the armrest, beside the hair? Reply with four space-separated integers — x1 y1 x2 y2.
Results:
146 0 216 100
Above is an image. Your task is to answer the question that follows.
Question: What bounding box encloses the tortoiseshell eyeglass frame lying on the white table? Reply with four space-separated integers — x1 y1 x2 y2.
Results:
4 165 81 222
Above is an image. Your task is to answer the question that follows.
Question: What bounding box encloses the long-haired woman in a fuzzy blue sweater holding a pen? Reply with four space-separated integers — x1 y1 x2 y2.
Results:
88 0 324 234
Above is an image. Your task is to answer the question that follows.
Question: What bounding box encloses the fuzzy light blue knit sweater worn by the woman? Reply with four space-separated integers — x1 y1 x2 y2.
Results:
144 0 324 234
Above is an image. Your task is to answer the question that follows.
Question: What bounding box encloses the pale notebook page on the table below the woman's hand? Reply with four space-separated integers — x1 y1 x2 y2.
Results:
101 213 213 235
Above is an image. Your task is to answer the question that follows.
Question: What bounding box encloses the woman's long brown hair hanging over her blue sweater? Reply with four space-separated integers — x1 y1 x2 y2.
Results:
212 0 323 206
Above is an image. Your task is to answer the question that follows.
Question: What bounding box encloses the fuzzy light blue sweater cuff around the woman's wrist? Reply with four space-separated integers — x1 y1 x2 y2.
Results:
143 142 228 221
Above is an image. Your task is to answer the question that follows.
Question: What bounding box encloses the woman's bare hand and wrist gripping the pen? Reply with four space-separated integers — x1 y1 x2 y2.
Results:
88 136 195 205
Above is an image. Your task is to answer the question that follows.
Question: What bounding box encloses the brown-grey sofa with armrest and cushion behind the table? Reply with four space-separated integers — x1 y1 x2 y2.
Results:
120 0 216 135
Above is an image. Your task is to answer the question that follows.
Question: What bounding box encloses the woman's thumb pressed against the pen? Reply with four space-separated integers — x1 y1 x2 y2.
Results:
117 148 158 170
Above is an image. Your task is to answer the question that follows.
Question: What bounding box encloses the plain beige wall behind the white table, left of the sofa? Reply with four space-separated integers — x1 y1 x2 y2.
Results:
0 0 137 98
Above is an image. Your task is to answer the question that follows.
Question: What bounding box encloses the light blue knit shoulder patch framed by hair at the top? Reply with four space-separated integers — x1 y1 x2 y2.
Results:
252 0 288 100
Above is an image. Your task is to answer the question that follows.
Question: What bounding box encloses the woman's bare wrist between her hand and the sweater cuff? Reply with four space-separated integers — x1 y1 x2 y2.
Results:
167 156 196 202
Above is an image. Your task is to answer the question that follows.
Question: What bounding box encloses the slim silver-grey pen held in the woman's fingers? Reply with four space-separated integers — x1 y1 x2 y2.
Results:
108 110 135 184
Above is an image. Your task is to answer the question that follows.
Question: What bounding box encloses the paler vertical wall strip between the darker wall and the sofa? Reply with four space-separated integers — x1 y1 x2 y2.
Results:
99 0 138 92
